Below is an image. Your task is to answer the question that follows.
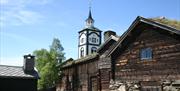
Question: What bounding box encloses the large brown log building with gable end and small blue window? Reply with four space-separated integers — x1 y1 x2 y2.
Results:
108 17 180 91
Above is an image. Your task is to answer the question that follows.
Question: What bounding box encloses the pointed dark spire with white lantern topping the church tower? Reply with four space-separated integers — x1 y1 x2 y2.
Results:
86 2 94 28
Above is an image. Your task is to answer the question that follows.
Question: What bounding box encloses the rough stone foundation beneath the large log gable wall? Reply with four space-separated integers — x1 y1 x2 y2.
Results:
109 80 180 91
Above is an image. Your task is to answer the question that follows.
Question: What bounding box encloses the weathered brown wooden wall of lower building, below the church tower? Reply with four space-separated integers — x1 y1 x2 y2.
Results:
58 59 98 91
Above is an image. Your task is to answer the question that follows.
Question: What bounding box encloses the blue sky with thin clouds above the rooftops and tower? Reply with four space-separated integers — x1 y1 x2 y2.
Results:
0 0 180 66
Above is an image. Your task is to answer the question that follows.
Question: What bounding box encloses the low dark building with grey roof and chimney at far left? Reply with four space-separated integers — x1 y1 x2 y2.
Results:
0 55 40 91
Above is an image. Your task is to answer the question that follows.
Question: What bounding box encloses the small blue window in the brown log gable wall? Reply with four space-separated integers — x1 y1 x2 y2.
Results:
140 48 152 60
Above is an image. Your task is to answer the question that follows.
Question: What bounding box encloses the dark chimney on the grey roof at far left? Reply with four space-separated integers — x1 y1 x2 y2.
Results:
23 54 35 72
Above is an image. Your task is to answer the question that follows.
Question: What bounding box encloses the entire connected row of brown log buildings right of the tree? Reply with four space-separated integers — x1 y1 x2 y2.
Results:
57 16 180 91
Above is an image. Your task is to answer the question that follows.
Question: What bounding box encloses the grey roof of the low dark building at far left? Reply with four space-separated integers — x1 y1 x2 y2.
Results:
0 65 39 79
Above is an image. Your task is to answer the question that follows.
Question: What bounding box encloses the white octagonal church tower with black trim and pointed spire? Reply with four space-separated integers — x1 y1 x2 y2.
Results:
78 8 102 58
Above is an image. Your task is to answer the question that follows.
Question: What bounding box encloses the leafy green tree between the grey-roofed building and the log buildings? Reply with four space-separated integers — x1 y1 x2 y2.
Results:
33 38 65 89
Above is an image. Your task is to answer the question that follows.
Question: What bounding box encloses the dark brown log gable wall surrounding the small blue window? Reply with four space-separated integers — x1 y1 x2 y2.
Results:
115 29 180 81
